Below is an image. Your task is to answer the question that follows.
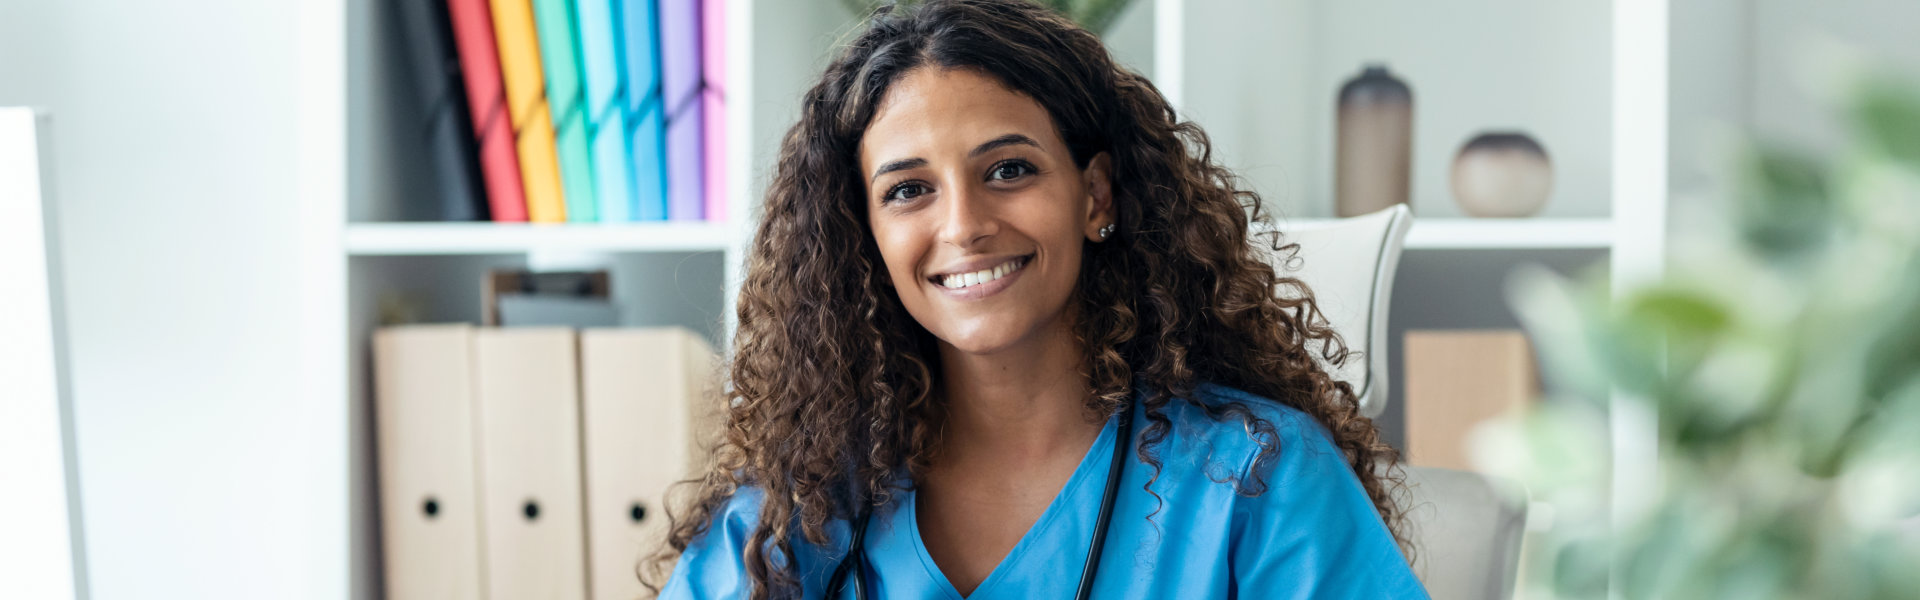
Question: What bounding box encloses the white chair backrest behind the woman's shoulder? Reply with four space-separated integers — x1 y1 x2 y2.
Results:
1271 204 1413 417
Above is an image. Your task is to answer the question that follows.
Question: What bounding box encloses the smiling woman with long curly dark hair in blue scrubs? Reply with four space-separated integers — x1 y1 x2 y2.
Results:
653 0 1425 598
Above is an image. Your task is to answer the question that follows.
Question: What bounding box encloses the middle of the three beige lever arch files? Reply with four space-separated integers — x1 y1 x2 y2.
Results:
474 327 588 600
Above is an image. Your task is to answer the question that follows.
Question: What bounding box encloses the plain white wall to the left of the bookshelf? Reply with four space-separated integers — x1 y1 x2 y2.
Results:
0 0 348 600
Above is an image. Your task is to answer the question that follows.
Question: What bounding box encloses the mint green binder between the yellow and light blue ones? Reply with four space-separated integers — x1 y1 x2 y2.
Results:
534 0 599 223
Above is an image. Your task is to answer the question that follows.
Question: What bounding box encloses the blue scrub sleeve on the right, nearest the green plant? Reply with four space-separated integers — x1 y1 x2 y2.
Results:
1231 412 1427 598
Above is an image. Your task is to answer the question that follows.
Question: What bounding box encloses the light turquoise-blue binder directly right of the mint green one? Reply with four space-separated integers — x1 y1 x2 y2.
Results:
574 0 636 223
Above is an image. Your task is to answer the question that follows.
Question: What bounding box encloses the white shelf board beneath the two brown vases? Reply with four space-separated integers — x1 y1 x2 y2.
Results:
1283 217 1615 250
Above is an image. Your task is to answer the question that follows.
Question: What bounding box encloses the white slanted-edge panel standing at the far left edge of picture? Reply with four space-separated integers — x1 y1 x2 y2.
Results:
0 108 86 598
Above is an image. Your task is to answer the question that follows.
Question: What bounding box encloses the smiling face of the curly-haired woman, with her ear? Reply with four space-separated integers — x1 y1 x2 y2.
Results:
860 67 1114 354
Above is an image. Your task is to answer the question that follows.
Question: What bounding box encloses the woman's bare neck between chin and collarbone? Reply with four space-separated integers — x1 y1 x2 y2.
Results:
941 319 1102 465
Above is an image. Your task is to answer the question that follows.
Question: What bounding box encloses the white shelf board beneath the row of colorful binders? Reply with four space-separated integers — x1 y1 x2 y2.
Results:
346 221 733 256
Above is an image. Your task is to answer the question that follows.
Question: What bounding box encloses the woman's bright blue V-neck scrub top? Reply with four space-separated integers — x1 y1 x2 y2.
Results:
660 385 1427 600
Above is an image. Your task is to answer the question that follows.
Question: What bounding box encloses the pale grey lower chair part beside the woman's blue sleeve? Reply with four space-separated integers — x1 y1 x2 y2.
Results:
1400 467 1526 598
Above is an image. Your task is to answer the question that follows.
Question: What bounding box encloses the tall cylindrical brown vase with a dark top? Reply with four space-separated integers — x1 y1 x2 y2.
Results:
1334 63 1413 217
